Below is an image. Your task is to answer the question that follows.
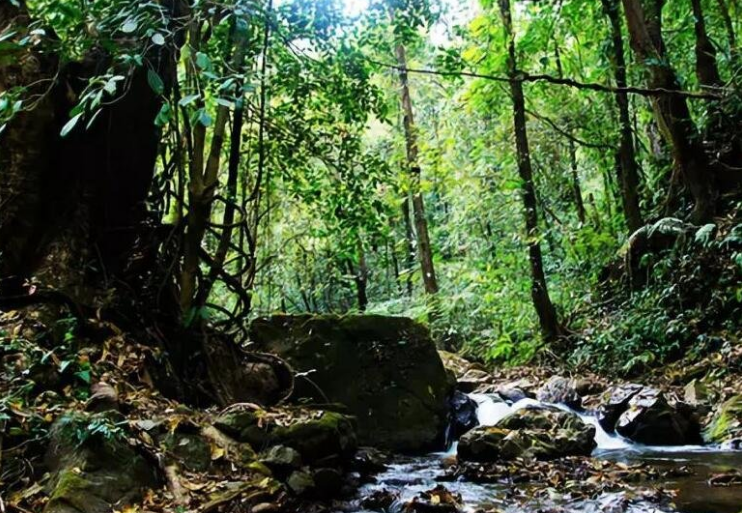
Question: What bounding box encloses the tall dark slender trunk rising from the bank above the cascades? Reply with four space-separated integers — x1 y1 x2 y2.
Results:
499 0 561 342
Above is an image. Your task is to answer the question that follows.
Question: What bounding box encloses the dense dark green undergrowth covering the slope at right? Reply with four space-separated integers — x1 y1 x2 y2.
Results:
568 210 742 374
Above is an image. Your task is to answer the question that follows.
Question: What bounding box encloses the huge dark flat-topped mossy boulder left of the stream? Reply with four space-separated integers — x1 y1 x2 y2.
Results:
250 315 450 452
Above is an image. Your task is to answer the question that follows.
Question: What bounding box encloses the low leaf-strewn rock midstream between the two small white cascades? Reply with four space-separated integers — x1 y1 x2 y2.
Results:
458 408 596 462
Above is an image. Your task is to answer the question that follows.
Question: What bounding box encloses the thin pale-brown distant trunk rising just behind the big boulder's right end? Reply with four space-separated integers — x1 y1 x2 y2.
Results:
396 44 438 295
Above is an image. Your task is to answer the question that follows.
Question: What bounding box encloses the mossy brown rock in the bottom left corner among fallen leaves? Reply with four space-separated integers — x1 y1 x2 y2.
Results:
44 413 158 513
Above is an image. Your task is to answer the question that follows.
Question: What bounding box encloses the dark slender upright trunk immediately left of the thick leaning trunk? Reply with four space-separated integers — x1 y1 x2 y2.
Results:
603 0 644 232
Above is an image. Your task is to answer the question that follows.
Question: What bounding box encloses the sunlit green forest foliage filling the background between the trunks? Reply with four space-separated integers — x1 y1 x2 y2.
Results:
7 0 742 372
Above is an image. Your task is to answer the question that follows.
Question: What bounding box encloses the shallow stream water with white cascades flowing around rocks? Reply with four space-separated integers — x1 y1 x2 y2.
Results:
350 394 742 513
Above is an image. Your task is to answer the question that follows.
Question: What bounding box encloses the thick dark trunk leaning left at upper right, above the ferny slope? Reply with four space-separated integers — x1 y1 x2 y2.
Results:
622 0 717 222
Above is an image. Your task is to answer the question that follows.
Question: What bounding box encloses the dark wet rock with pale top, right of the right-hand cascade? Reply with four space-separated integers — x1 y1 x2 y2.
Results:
616 388 702 445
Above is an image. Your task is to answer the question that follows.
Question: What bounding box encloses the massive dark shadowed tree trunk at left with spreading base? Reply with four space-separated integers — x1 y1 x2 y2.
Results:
0 1 292 405
